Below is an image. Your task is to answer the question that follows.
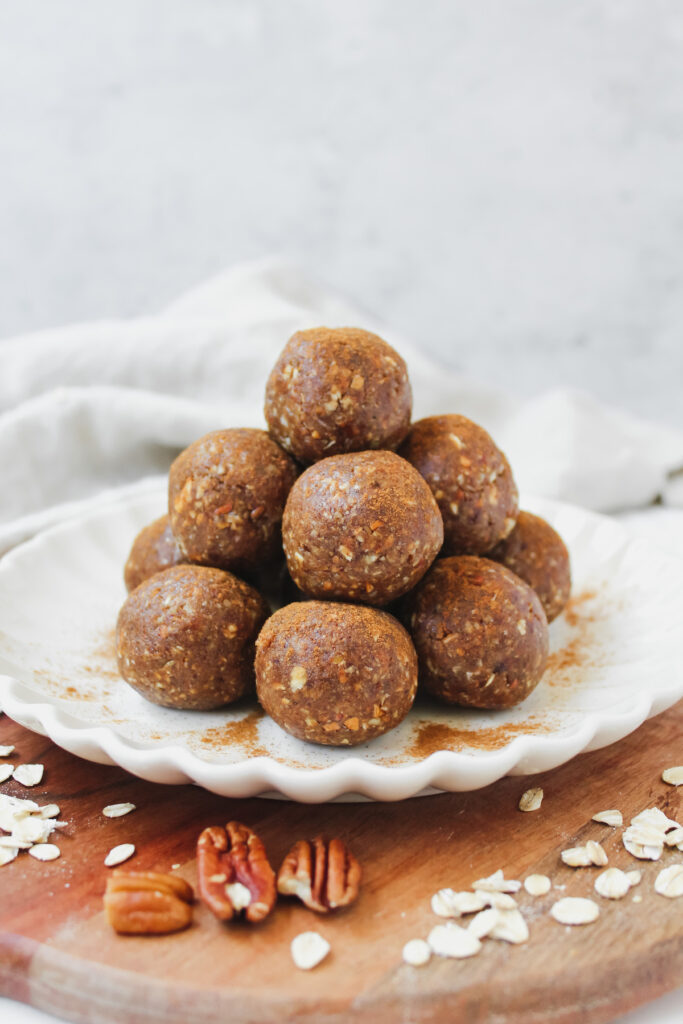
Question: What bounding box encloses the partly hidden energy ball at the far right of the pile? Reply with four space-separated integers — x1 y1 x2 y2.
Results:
486 512 571 623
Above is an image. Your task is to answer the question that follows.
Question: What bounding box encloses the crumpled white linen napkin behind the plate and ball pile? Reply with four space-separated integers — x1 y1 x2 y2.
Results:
0 262 683 554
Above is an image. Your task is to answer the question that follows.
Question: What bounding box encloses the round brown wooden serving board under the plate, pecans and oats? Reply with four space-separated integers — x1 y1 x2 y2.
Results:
0 702 683 1024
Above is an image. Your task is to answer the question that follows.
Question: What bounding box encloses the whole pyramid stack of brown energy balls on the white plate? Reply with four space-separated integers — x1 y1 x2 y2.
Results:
117 328 570 745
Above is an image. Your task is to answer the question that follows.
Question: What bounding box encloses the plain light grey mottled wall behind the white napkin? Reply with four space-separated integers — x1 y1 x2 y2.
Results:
0 0 683 426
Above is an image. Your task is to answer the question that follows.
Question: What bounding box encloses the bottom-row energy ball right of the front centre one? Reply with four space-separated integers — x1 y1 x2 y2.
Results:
407 555 548 708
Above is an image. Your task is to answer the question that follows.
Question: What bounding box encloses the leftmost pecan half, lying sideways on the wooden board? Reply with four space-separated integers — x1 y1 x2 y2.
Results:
104 869 195 935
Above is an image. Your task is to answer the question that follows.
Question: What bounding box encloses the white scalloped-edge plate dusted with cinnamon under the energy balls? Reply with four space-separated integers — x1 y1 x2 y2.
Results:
0 489 683 802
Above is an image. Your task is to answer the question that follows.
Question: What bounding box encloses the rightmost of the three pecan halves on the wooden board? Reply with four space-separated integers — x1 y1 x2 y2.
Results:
278 836 360 913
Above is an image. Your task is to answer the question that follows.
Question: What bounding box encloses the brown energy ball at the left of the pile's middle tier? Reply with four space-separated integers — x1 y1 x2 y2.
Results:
168 429 297 572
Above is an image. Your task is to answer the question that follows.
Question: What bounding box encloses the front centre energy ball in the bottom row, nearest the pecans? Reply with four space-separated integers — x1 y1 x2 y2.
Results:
256 601 418 746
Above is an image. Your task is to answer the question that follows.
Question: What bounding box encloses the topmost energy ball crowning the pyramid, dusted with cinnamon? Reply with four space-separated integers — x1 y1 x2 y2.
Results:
265 327 413 464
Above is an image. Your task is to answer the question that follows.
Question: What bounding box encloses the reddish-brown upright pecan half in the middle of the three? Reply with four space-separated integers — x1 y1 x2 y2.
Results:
197 821 278 924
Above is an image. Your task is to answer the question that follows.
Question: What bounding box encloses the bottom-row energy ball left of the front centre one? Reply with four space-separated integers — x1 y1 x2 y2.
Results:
116 565 268 711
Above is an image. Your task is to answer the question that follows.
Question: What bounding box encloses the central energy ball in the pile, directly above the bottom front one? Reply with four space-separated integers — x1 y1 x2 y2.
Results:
283 452 443 604
